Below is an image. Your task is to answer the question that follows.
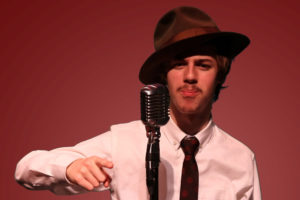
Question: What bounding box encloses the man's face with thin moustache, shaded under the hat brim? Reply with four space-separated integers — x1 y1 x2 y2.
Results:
167 55 218 115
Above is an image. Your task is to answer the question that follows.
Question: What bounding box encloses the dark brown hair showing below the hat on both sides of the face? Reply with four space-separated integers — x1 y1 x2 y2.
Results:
158 55 232 102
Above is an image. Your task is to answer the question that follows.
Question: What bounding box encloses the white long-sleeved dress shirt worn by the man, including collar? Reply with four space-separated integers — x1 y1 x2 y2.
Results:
15 119 261 200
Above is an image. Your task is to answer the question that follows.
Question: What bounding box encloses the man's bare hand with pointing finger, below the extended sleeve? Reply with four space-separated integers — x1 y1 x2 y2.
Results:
66 156 113 190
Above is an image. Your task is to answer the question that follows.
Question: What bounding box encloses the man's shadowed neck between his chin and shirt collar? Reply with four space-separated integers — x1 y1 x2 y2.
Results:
170 105 211 135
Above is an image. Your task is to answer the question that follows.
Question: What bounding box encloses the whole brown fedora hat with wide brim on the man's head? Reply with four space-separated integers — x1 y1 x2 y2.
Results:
139 6 250 84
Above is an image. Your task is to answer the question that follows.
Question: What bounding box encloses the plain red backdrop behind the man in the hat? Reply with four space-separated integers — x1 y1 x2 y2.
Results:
0 0 300 200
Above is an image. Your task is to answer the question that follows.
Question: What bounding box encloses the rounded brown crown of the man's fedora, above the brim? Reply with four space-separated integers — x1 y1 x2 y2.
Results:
154 6 220 50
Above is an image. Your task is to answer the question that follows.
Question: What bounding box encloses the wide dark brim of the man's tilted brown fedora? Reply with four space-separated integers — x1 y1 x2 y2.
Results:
139 32 250 84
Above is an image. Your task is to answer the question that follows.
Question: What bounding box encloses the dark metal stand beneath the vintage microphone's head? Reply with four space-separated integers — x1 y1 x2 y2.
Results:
146 125 160 200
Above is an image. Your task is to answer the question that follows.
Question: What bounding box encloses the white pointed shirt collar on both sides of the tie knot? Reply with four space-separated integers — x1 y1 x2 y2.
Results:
161 117 215 149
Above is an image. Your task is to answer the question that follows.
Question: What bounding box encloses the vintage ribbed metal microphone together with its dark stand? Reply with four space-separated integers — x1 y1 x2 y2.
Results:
140 84 169 200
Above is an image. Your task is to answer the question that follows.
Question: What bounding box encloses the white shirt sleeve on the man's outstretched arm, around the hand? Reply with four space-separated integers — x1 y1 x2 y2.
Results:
15 131 113 194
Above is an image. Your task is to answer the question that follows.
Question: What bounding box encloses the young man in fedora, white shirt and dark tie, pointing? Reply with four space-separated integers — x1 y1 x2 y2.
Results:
15 7 261 200
